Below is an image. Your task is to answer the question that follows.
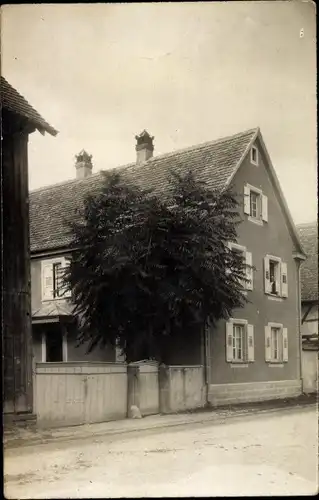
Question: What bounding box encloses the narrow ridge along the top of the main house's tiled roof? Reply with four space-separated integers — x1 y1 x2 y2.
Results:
30 127 259 193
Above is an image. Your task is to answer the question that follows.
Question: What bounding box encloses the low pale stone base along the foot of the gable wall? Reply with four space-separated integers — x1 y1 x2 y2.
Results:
208 380 302 406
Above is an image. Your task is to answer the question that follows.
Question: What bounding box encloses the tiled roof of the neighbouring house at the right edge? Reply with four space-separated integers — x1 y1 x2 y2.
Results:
297 222 318 301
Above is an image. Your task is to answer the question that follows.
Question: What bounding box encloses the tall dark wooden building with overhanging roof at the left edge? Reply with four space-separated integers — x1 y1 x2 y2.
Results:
1 77 57 418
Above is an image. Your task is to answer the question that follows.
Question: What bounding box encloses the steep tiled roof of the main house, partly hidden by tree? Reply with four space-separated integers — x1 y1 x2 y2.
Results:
30 129 259 252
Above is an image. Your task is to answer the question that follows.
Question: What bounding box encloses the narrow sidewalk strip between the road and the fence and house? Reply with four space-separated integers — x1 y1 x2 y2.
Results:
3 395 317 449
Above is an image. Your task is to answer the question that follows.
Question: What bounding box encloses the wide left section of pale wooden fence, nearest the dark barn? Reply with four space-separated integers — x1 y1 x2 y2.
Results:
35 362 127 426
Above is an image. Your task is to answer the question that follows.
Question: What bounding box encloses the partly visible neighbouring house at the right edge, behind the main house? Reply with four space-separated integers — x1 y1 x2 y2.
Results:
297 222 319 392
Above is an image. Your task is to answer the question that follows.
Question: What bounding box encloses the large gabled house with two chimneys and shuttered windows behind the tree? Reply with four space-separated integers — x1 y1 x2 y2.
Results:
30 128 305 405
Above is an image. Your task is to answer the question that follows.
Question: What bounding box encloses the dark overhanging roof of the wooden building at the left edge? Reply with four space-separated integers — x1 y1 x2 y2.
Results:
0 76 58 135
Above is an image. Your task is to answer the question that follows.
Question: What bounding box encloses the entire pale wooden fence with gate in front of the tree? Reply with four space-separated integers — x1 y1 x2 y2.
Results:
34 362 204 427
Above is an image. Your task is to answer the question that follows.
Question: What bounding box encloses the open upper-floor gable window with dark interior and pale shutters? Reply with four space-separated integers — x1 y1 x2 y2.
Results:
264 255 288 297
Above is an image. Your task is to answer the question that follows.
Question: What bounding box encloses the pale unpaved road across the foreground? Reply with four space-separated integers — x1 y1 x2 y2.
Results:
4 407 318 499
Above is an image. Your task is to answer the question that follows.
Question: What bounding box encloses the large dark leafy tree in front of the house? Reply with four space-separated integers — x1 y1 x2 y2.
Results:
65 172 246 362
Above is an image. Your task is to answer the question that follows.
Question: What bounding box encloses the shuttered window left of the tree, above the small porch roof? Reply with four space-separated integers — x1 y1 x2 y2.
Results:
41 257 71 301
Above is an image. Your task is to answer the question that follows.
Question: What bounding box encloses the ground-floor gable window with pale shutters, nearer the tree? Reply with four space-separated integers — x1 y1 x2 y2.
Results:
226 319 254 363
